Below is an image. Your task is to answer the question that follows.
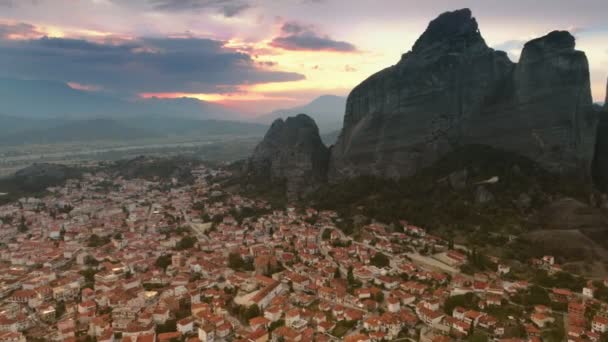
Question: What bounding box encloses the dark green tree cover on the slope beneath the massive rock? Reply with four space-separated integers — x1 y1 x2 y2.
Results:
310 145 589 233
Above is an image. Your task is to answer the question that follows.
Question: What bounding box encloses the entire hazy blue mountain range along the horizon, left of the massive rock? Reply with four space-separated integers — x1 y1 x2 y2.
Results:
0 78 346 145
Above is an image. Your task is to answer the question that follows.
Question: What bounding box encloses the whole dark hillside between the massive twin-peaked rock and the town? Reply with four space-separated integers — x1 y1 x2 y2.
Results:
308 145 608 267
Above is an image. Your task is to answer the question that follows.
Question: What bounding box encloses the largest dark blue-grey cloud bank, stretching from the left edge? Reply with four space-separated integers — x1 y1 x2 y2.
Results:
0 37 304 94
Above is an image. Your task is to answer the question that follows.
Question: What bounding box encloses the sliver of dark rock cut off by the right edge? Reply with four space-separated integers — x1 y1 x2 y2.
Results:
593 76 608 193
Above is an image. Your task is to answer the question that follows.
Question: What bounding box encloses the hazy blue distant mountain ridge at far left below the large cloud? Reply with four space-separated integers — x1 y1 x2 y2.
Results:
0 78 240 120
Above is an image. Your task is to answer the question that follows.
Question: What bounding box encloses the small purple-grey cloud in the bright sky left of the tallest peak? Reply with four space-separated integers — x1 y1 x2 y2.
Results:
270 22 357 52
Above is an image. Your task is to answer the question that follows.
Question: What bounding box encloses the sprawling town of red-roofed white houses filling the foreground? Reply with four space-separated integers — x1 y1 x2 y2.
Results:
0 166 608 342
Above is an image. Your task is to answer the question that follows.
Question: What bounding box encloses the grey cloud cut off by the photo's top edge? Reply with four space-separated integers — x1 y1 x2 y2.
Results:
149 0 251 17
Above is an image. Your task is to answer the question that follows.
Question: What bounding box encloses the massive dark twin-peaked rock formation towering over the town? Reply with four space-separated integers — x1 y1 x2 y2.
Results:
329 9 597 180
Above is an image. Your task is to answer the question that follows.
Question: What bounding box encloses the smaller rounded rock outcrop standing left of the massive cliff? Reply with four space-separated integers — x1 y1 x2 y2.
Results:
247 114 329 199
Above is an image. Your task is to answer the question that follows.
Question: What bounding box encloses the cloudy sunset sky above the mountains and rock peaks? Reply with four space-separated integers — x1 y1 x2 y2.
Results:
0 0 608 115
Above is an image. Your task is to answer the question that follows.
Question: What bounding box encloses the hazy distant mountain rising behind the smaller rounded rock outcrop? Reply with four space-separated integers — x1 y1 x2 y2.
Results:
255 95 346 133
